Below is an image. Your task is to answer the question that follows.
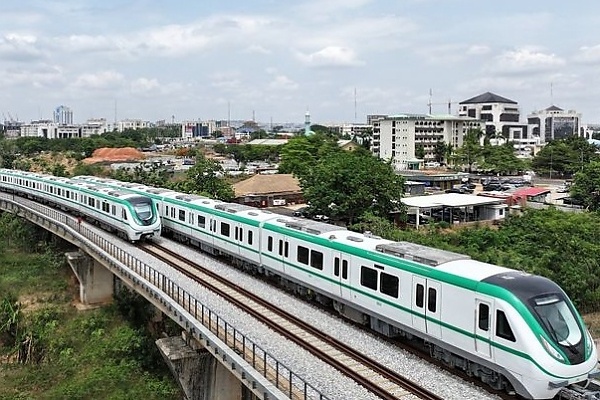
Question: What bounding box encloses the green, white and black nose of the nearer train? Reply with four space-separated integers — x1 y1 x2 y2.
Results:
482 271 599 399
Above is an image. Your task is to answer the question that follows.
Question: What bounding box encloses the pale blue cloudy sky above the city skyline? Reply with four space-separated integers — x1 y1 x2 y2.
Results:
0 0 600 123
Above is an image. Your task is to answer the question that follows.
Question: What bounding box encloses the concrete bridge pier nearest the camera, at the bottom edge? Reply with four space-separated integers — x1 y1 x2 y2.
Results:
156 336 246 400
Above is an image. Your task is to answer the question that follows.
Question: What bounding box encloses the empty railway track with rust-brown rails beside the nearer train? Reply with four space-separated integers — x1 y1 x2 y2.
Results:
140 243 441 400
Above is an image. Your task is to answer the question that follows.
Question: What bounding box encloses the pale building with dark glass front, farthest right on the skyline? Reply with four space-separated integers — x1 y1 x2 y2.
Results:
527 105 581 143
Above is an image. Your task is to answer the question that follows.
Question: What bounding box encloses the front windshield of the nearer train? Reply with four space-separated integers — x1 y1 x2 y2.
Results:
532 294 583 347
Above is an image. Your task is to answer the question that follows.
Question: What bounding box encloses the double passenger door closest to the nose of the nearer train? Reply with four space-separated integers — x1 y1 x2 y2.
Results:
411 276 442 337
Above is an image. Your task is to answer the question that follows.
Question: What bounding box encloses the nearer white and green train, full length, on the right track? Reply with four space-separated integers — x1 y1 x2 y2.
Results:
68 177 598 399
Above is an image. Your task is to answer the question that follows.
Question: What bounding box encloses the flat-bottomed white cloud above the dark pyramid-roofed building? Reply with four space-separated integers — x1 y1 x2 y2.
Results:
488 48 565 74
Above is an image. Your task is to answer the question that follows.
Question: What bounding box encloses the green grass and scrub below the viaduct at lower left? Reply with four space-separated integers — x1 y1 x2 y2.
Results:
0 245 181 400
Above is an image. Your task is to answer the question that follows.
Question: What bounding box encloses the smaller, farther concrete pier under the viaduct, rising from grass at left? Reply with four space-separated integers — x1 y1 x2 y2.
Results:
65 251 113 305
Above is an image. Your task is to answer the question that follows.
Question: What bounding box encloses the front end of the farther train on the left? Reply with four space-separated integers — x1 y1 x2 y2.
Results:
122 194 161 240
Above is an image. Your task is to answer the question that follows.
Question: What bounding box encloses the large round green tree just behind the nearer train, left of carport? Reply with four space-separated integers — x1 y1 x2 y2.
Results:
299 148 404 224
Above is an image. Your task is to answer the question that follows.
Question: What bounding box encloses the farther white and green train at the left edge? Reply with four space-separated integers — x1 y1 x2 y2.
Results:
0 169 162 242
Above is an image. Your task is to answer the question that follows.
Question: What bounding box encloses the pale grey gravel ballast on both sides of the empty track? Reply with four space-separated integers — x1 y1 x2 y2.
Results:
57 214 499 400
